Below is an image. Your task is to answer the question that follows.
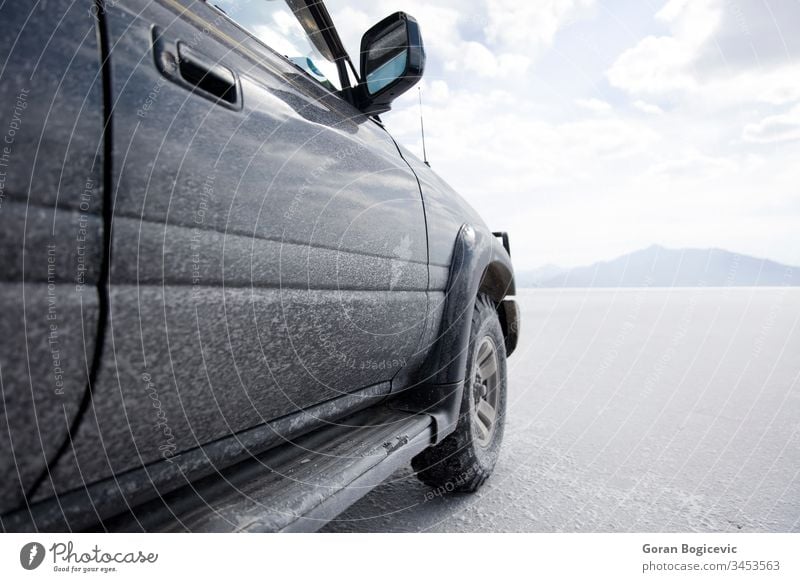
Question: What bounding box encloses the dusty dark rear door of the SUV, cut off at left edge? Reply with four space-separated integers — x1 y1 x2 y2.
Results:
0 0 104 513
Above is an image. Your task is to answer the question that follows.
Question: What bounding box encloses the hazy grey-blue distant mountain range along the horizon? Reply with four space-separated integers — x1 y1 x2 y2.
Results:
517 245 800 287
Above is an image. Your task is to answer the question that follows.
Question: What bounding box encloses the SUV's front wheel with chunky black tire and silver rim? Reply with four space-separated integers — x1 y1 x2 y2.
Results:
411 295 507 493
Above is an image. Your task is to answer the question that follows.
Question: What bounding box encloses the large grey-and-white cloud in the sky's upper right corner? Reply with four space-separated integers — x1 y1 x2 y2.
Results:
607 0 800 106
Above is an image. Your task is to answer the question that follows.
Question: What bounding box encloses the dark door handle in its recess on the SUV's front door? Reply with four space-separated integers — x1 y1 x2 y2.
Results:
153 27 242 109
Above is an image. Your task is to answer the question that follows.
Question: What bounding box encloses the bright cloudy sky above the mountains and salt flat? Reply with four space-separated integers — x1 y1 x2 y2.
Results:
326 0 800 270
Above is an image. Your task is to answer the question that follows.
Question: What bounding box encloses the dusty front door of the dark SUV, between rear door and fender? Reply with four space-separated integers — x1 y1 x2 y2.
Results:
49 0 427 498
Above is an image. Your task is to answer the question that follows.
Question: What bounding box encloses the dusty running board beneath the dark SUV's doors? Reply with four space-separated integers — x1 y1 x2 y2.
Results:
103 406 435 532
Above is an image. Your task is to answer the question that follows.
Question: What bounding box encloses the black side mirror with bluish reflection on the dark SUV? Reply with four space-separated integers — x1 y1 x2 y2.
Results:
356 12 425 115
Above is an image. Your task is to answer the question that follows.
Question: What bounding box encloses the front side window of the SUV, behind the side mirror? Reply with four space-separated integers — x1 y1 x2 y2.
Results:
209 0 342 91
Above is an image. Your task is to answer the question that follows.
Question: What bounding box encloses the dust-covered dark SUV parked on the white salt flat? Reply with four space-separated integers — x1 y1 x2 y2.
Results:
0 0 519 531
